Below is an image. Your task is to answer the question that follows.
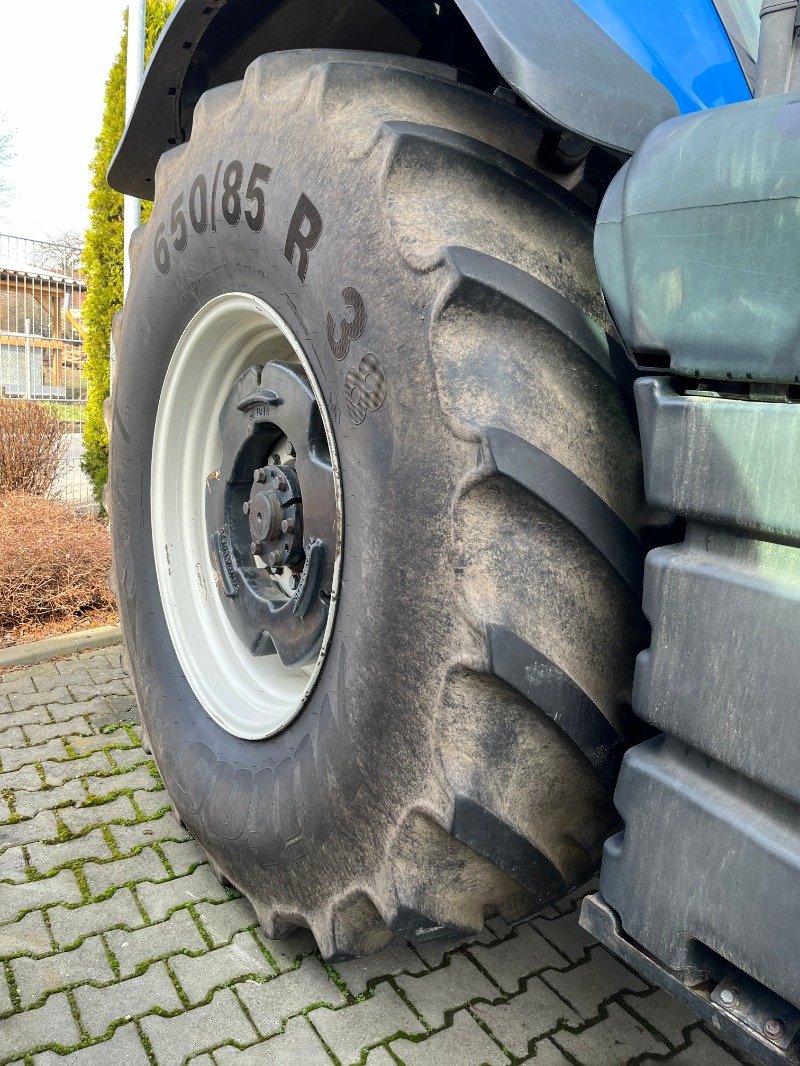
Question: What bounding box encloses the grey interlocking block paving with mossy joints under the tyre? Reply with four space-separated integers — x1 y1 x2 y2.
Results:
0 648 740 1066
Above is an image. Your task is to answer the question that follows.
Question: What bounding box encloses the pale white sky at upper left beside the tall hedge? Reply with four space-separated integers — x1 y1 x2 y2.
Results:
0 0 133 240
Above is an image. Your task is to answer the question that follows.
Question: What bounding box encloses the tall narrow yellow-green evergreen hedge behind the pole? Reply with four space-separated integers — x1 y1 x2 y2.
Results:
82 0 174 506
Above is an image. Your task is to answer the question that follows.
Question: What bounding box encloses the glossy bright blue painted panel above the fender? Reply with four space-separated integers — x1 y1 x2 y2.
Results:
576 0 751 114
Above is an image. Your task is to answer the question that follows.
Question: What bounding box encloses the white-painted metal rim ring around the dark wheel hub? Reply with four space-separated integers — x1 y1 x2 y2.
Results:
150 293 343 740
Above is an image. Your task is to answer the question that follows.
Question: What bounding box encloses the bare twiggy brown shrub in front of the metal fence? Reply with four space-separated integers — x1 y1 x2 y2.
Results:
0 399 67 496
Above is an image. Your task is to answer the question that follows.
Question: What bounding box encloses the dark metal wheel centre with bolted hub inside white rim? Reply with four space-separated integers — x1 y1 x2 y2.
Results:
206 362 336 666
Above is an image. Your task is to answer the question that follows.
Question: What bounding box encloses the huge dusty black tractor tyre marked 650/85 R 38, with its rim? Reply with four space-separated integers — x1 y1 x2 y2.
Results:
110 51 644 958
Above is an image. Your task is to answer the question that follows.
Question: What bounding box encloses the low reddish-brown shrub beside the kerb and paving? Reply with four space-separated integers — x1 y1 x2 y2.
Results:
0 492 114 630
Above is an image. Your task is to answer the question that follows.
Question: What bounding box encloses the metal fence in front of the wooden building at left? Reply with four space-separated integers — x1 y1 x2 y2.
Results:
0 233 93 510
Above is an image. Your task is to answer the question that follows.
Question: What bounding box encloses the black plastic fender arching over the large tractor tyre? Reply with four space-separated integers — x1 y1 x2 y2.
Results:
109 0 677 199
